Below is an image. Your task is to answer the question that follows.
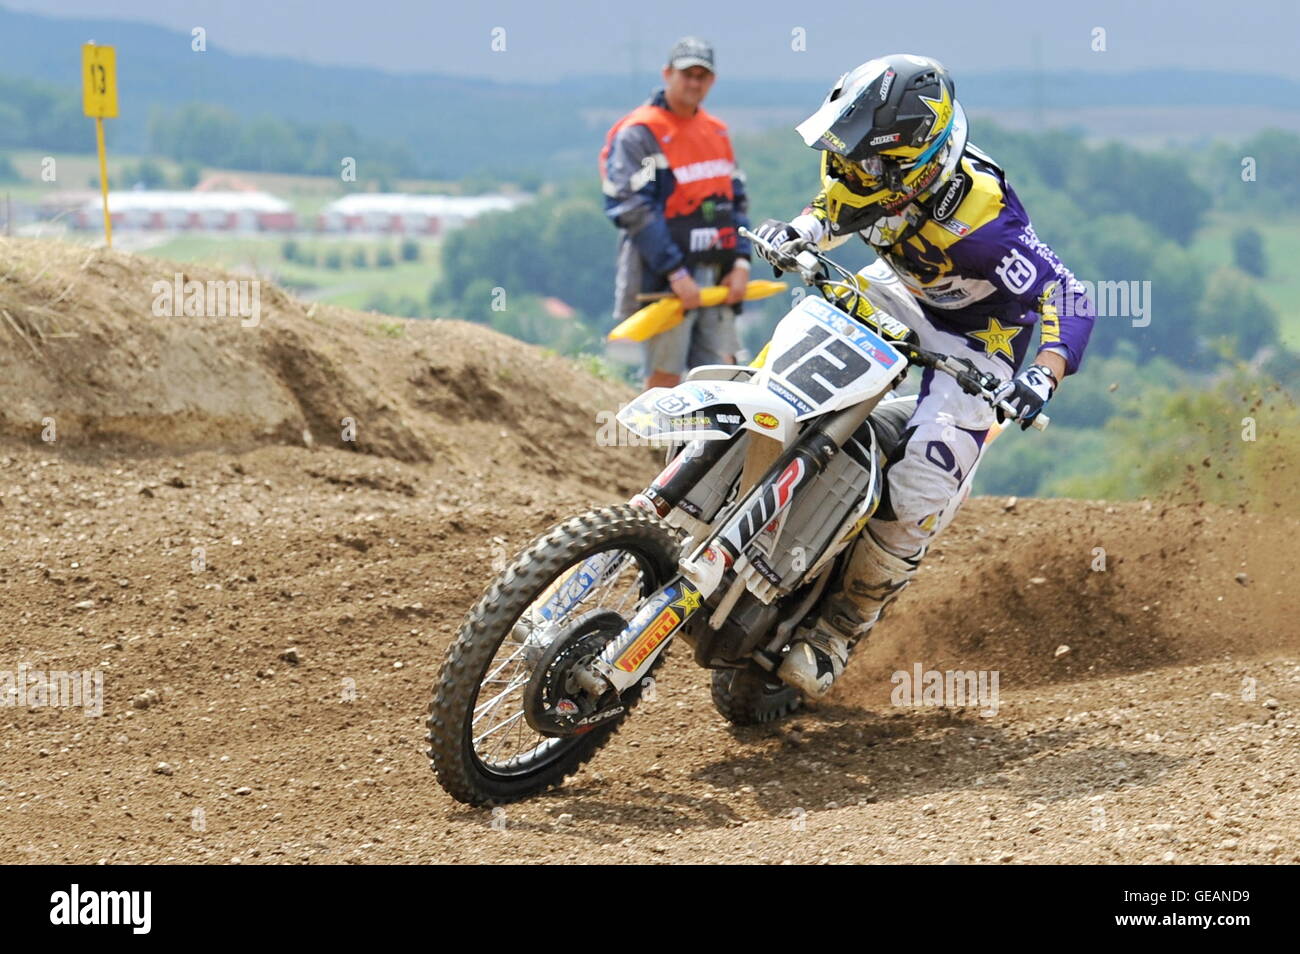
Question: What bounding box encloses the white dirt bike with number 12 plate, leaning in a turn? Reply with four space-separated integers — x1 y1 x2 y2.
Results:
428 231 1048 805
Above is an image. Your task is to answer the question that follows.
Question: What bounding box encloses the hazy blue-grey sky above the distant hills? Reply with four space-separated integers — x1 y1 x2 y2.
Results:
10 0 1300 81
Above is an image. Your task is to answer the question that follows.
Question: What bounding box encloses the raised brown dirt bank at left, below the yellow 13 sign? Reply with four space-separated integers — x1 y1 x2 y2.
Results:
0 239 646 493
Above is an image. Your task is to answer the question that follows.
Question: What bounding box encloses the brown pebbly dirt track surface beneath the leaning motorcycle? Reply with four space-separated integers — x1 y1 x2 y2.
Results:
0 240 1300 863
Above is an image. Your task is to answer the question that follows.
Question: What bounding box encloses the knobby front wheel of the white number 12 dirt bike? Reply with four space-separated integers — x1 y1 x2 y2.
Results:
428 506 680 805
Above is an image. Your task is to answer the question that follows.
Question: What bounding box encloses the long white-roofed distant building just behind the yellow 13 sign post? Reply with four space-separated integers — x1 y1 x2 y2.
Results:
72 190 298 231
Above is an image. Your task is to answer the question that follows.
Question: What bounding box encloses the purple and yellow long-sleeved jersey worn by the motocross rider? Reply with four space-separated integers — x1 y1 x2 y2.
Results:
807 146 1093 374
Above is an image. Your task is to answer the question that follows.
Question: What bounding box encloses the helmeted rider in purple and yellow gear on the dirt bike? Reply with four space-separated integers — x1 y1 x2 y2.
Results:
755 55 1093 697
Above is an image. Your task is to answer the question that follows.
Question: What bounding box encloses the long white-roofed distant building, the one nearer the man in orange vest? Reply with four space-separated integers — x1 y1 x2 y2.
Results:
317 192 525 235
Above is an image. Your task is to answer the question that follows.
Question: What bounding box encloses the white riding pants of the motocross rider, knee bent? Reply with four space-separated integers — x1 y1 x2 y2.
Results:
861 261 1011 558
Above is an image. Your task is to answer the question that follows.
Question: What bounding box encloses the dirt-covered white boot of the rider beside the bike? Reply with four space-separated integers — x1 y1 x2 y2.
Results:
776 530 926 698
